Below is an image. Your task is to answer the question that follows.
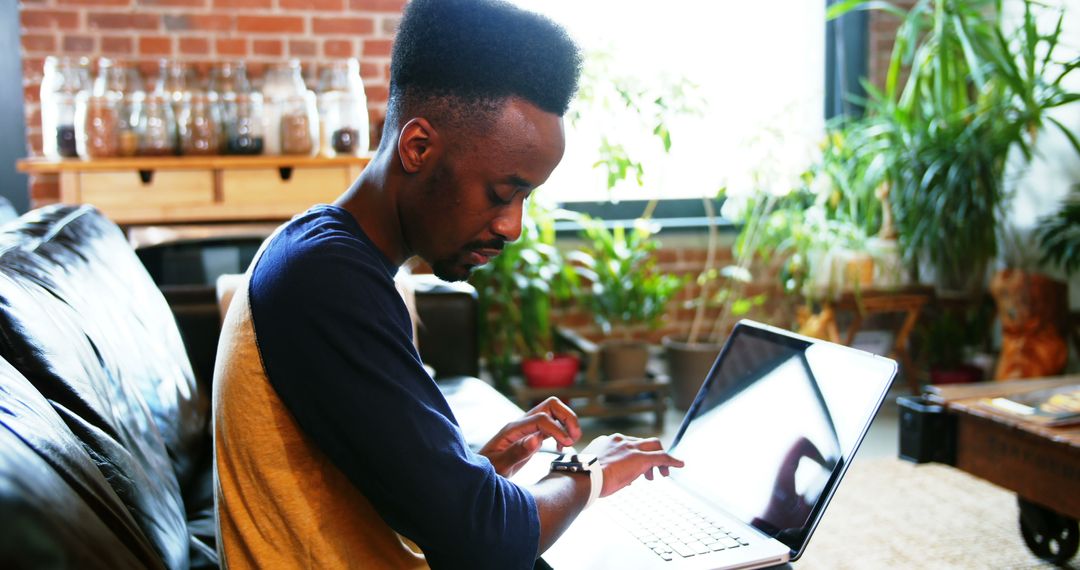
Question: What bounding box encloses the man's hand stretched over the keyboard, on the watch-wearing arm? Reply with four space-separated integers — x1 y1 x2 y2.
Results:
583 434 684 497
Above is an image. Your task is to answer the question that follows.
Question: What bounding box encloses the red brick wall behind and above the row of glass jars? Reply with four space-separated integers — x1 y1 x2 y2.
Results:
19 0 405 207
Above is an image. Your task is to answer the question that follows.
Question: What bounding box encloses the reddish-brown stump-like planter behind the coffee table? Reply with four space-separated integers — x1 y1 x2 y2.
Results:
990 269 1069 380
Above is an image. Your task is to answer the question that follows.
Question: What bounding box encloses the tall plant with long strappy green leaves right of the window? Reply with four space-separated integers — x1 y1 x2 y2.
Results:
829 0 1080 295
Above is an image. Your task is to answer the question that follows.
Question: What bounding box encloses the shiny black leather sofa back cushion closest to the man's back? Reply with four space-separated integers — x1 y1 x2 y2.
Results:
0 206 192 568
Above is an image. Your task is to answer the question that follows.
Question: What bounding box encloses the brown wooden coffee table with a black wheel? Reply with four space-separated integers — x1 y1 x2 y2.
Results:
926 375 1080 562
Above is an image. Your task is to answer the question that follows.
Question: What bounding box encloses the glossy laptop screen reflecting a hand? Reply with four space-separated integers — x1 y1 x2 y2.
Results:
672 322 895 556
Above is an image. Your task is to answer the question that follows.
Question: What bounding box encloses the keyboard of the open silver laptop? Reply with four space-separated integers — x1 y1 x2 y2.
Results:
607 484 747 560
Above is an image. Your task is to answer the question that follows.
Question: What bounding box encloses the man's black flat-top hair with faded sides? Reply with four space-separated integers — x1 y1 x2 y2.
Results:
387 0 581 147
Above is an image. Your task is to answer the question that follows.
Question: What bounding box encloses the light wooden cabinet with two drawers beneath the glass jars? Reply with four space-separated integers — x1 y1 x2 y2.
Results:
18 157 369 226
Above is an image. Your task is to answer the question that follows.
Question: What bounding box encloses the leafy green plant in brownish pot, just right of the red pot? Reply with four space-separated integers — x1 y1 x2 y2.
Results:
567 216 684 380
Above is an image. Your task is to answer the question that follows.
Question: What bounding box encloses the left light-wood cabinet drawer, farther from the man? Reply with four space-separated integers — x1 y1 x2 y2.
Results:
79 169 214 209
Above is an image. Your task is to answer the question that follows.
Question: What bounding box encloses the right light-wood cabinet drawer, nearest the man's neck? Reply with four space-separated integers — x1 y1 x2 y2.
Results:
221 166 352 208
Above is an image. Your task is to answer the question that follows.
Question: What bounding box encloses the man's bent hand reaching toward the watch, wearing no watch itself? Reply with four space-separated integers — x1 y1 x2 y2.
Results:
480 396 581 477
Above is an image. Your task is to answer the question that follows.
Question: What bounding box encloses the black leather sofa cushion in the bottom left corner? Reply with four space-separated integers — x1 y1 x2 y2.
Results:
0 361 162 568
